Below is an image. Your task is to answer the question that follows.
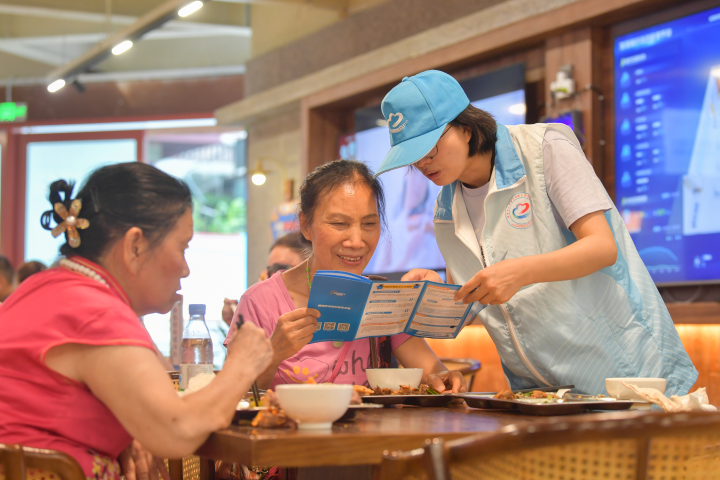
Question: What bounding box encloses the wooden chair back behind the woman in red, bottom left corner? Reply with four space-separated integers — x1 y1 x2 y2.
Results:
0 443 85 480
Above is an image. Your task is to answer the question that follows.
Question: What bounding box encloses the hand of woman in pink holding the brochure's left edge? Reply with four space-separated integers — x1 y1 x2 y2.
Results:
270 308 320 364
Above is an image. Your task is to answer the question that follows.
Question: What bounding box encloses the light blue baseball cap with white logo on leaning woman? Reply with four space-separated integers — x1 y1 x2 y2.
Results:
375 70 470 176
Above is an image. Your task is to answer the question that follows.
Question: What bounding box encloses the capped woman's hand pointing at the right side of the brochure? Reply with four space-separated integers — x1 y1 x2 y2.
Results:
455 258 527 305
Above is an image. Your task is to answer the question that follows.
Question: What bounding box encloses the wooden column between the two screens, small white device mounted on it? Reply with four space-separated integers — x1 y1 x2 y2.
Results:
545 27 611 179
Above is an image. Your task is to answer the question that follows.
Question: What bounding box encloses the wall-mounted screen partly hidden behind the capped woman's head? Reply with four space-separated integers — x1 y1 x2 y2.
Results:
339 64 526 276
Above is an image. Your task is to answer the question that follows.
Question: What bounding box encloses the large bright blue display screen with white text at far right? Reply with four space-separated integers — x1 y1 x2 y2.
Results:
614 8 720 283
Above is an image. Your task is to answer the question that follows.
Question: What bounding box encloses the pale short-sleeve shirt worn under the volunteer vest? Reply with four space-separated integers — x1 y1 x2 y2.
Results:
462 131 612 245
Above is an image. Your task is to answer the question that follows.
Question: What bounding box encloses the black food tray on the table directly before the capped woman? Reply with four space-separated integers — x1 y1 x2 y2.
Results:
453 393 645 415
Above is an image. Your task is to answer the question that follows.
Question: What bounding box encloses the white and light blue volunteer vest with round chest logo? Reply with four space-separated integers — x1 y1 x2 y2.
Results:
434 124 698 397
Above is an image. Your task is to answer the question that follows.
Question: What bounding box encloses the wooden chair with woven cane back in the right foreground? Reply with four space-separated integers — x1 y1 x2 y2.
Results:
378 413 720 480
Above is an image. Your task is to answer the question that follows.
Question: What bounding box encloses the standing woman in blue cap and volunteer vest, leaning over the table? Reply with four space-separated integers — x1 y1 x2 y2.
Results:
378 70 698 396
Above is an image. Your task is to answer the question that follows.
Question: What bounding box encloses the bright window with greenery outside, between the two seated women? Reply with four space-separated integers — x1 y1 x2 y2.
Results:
145 131 247 368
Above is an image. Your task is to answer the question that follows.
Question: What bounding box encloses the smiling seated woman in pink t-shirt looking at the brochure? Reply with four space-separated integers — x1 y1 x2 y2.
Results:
226 160 467 392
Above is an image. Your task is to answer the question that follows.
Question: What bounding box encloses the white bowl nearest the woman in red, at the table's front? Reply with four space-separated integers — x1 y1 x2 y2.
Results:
275 383 353 430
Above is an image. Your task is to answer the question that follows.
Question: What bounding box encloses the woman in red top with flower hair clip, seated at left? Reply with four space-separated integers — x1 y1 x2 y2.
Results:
0 162 272 480
